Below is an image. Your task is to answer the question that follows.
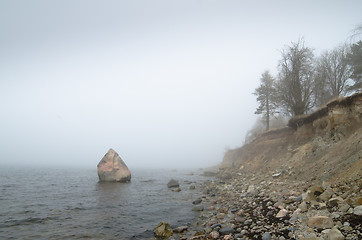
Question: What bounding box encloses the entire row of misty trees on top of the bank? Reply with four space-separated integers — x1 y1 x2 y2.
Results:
253 39 362 130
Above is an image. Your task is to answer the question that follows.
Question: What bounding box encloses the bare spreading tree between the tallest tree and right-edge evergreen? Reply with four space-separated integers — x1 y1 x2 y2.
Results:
317 45 352 98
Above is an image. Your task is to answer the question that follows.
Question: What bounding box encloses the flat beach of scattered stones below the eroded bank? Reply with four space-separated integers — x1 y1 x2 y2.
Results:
154 172 362 240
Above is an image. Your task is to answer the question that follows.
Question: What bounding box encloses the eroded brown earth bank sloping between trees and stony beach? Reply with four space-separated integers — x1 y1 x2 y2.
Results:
220 93 362 182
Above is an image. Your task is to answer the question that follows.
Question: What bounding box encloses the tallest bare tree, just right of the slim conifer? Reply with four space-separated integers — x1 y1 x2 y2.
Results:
277 39 314 116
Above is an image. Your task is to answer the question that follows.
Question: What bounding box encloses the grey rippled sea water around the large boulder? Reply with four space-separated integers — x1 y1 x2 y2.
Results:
0 167 211 239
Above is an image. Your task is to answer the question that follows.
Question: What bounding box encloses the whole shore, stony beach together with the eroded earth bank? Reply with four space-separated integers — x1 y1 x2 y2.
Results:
148 92 362 240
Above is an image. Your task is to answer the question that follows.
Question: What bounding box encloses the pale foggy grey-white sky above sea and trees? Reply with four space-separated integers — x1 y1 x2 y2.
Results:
0 0 362 170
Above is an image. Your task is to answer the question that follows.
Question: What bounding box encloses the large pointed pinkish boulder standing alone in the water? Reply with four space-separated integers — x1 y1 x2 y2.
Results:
97 148 131 182
